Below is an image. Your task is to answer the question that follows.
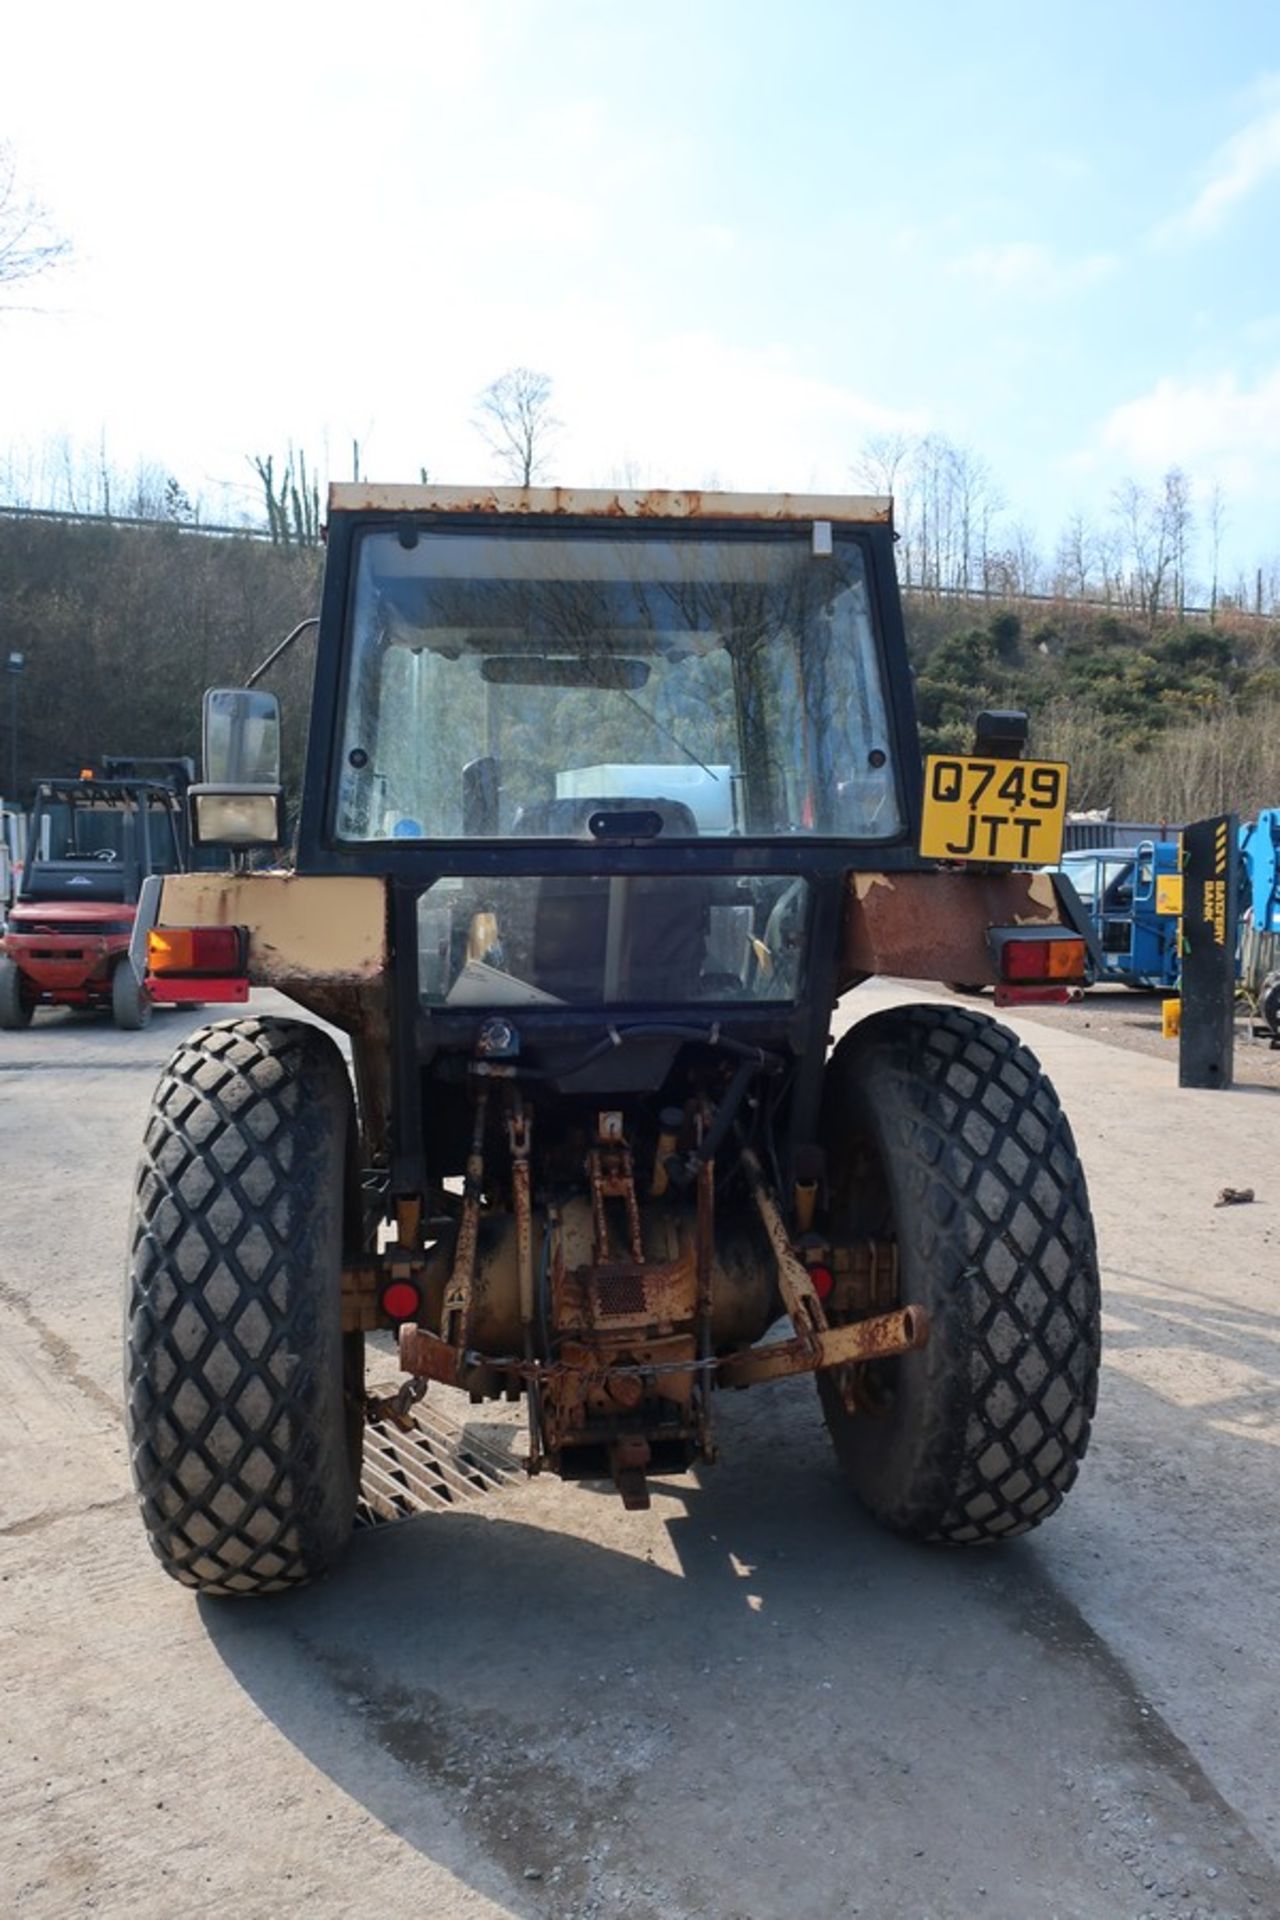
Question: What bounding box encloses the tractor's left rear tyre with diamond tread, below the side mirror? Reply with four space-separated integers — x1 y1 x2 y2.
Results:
125 1020 365 1594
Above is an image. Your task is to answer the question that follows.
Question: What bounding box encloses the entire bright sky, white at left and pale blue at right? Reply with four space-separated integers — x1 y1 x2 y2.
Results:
0 0 1280 583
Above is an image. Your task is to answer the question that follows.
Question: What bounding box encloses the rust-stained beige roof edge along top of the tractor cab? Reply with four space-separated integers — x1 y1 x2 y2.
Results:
328 480 892 526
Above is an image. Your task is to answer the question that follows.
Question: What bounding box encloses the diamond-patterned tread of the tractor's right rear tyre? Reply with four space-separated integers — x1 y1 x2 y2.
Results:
823 1006 1102 1544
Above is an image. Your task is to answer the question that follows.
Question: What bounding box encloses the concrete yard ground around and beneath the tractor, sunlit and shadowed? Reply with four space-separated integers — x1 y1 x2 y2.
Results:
0 983 1280 1920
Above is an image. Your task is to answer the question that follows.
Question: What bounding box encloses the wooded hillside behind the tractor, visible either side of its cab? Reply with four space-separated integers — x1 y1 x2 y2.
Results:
0 516 1280 820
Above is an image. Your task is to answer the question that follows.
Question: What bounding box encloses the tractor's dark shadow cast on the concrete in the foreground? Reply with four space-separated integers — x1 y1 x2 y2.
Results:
201 1388 1280 1920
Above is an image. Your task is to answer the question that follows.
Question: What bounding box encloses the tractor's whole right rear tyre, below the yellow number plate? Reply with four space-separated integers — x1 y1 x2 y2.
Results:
819 1006 1100 1544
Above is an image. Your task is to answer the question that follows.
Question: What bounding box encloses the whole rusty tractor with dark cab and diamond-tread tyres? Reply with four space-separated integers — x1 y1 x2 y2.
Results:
127 484 1100 1596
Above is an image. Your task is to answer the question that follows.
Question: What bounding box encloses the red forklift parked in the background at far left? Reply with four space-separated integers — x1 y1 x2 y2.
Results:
0 756 192 1031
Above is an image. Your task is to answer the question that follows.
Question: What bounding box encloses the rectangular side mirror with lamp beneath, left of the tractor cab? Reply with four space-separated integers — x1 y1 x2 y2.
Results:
188 687 284 847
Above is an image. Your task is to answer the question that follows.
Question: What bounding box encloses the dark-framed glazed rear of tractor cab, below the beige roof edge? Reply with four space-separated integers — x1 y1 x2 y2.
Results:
314 516 915 1012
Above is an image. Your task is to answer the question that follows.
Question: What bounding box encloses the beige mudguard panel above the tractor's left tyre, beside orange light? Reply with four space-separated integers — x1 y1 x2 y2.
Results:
155 874 388 993
